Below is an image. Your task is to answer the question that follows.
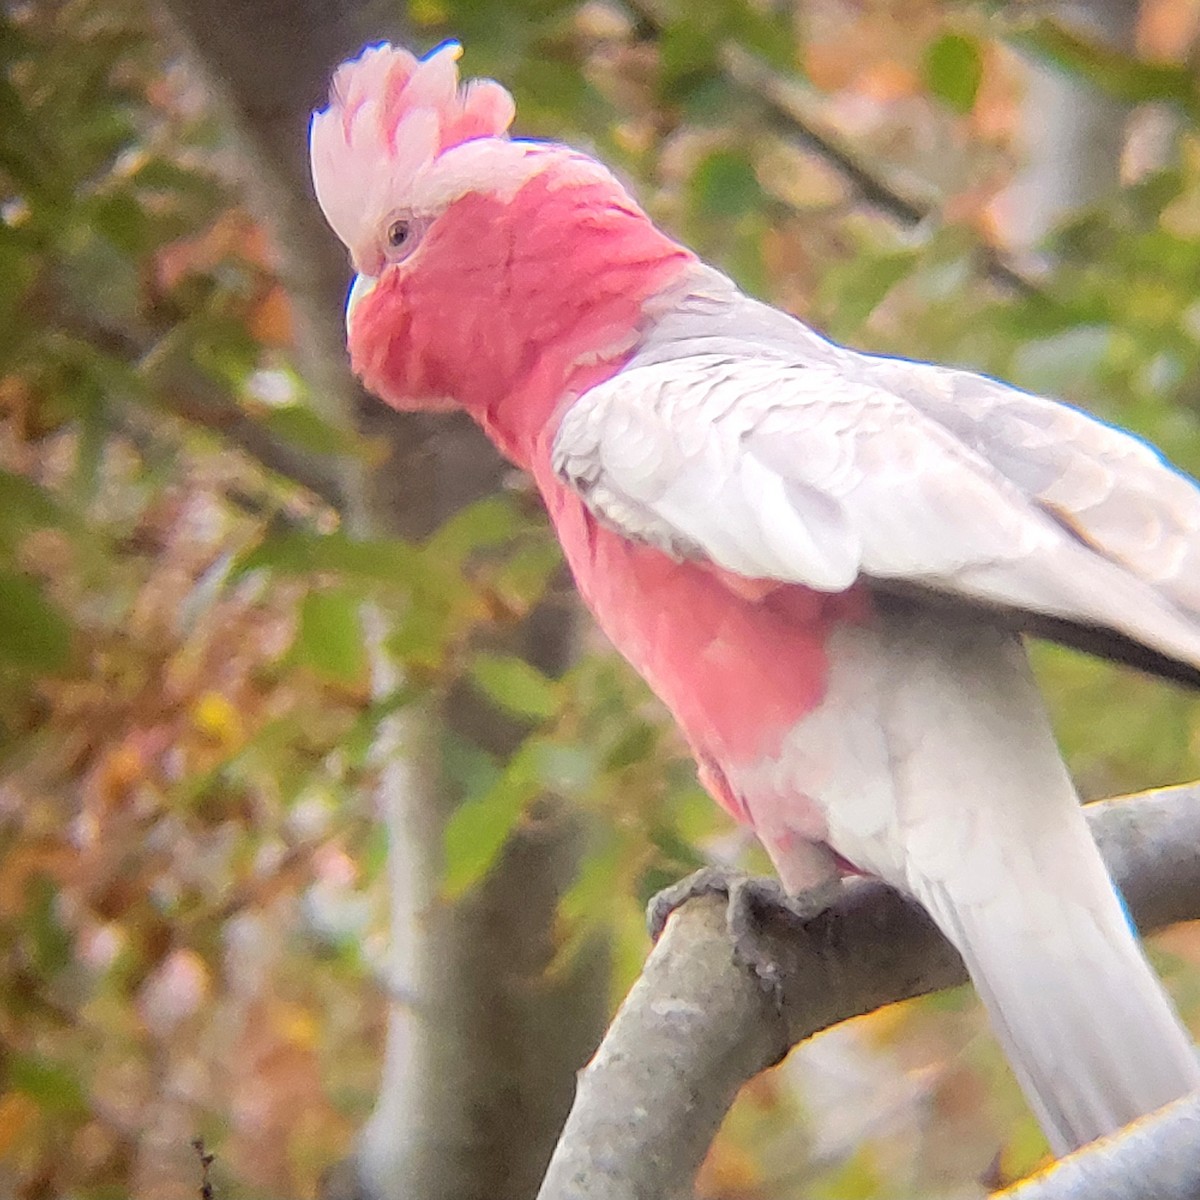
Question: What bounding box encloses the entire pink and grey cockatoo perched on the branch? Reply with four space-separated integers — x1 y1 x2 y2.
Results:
311 44 1200 1152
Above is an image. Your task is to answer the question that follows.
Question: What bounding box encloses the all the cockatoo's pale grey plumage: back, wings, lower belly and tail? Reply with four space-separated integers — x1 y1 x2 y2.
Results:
553 268 1200 1152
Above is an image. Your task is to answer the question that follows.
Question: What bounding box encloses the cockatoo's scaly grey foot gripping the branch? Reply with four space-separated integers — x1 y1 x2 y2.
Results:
646 866 840 1003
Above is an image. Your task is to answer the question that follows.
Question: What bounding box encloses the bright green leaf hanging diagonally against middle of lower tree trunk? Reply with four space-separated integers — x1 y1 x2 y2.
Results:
442 742 541 900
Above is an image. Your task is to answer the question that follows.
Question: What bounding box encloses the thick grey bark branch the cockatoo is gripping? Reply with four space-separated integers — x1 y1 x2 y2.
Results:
539 786 1200 1200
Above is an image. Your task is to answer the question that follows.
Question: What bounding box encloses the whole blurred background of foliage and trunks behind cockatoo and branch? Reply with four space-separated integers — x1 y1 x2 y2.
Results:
0 0 1200 1200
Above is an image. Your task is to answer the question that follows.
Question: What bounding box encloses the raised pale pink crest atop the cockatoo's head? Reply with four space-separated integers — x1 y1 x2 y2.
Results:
310 42 516 252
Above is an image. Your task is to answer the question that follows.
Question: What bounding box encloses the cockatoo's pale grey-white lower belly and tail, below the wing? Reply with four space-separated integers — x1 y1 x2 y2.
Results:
727 607 1200 1153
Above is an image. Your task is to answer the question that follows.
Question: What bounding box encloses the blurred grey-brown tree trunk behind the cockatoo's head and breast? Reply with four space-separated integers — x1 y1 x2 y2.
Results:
156 0 607 1200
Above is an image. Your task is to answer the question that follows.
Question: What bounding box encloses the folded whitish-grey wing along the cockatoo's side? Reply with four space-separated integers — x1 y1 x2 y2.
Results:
553 352 1200 683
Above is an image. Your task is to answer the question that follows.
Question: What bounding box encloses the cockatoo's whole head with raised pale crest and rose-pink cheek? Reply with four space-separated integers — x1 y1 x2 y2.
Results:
311 42 692 452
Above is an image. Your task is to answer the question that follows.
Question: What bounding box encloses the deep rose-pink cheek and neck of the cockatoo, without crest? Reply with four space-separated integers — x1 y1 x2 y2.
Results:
350 148 695 467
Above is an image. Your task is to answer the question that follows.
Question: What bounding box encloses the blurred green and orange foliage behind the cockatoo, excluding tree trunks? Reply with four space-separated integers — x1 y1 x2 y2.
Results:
0 0 1200 1200
